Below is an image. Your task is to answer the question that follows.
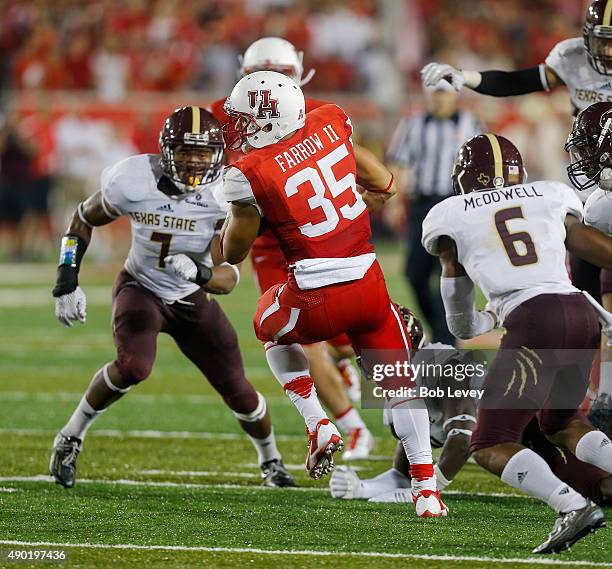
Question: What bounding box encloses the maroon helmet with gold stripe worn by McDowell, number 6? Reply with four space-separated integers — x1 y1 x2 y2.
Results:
452 133 527 195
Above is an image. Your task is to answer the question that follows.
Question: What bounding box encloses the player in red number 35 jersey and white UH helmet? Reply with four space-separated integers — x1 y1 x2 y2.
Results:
221 71 448 517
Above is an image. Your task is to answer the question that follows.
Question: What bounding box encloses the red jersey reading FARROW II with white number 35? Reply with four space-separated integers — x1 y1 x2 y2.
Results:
228 104 374 263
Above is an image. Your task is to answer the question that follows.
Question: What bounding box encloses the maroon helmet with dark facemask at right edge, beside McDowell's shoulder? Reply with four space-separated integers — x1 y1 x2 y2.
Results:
565 101 612 190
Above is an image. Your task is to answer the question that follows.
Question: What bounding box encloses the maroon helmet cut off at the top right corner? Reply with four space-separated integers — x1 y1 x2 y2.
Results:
582 0 612 75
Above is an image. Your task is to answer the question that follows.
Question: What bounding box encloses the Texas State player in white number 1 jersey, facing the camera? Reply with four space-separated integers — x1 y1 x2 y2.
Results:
49 107 295 488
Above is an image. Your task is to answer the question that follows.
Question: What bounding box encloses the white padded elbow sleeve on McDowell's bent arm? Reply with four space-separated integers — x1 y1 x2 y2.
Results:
440 276 495 340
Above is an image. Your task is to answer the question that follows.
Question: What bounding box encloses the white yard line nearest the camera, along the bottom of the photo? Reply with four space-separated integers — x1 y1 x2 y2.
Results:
0 539 612 567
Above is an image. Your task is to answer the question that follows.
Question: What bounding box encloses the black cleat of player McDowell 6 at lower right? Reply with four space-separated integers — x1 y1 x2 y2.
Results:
533 500 606 553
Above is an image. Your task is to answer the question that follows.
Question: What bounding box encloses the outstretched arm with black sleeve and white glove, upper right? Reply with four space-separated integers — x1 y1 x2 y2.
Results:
421 63 565 97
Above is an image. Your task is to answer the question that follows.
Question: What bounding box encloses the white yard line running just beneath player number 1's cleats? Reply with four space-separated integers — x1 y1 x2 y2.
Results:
0 470 534 500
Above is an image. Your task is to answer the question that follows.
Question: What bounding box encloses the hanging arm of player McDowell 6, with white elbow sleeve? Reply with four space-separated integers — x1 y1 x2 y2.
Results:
438 236 497 340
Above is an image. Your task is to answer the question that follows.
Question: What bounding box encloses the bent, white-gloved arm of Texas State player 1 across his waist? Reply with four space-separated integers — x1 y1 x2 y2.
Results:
164 236 240 294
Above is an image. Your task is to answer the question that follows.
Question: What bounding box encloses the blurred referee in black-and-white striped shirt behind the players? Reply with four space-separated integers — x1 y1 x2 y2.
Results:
387 80 484 344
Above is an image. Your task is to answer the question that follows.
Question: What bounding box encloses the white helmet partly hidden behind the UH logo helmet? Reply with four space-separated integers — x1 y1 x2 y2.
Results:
238 37 315 86
